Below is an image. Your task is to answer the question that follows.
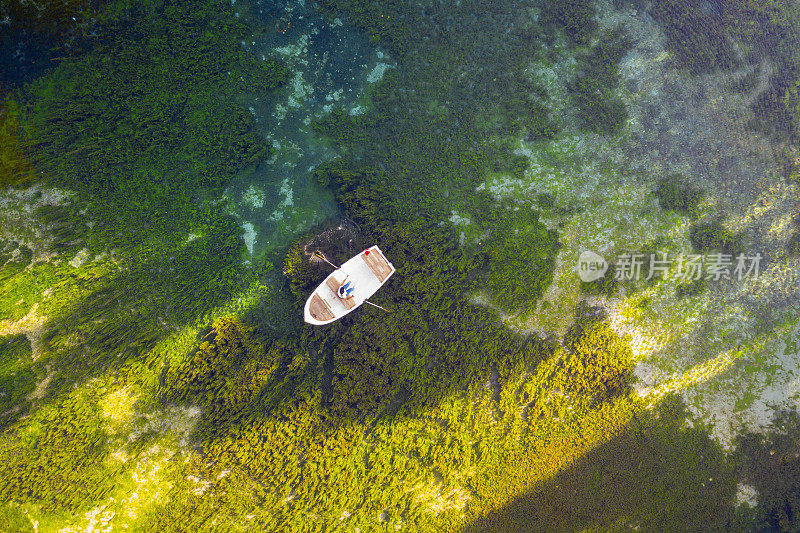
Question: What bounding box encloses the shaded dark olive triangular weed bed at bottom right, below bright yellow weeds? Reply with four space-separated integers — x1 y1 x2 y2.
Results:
463 392 741 532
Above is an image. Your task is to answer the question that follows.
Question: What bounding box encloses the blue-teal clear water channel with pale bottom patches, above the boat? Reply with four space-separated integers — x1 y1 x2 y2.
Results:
226 0 391 255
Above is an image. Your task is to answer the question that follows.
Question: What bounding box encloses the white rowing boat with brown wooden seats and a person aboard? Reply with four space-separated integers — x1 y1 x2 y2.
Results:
303 245 395 326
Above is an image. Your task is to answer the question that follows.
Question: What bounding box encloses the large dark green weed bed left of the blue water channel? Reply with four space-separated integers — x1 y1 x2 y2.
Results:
0 2 288 416
